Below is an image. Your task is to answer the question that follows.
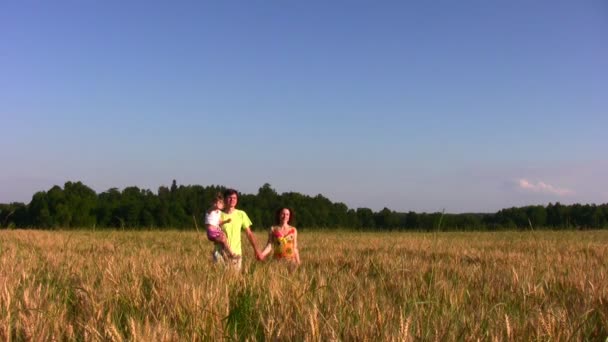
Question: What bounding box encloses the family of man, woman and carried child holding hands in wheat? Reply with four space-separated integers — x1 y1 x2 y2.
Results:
205 189 300 269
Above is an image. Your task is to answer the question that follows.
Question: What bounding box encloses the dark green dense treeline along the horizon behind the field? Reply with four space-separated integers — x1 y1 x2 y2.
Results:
0 180 608 230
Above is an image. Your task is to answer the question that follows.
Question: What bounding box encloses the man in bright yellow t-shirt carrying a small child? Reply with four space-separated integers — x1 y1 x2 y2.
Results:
213 189 261 270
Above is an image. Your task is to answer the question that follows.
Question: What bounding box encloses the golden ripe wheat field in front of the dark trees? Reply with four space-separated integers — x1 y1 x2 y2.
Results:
0 230 608 341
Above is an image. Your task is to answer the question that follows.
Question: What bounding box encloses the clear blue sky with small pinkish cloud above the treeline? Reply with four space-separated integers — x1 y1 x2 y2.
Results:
0 0 608 213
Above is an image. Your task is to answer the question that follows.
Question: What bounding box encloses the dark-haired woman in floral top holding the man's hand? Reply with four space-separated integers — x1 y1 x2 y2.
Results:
260 208 300 265
